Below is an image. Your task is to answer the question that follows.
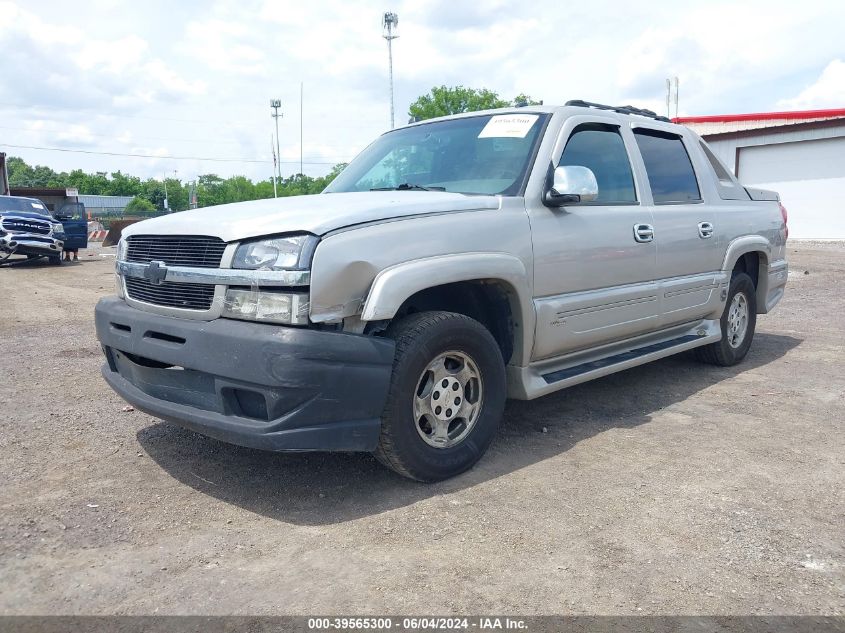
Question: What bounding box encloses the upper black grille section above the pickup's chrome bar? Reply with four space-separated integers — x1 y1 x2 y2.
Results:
126 235 226 268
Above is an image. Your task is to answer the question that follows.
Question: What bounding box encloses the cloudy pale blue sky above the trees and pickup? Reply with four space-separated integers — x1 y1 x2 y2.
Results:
0 0 845 180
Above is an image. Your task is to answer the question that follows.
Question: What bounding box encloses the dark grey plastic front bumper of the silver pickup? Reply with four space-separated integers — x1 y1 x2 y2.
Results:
96 297 394 451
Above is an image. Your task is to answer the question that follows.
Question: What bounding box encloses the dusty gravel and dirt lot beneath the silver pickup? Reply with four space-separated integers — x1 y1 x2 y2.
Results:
0 244 845 614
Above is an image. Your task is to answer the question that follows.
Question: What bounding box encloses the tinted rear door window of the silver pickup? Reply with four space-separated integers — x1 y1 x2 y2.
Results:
634 129 701 204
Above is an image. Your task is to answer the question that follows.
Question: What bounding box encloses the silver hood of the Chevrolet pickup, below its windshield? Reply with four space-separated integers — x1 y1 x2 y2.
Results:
123 191 500 242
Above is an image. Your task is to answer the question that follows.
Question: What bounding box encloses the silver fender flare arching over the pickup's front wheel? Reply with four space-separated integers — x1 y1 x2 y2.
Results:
361 253 534 324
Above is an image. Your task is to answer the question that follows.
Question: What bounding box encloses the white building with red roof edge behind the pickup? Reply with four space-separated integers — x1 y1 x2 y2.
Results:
674 108 845 239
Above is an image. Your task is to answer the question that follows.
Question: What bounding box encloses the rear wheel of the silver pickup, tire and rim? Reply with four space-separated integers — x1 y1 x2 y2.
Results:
695 273 757 367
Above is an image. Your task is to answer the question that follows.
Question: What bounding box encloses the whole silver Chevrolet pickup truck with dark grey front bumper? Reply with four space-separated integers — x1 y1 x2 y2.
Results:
96 101 787 481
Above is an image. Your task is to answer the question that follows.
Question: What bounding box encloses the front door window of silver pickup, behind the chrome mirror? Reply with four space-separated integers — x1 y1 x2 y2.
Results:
558 123 637 204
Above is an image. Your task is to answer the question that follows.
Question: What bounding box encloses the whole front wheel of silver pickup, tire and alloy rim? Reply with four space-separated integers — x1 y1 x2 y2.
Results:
376 312 506 481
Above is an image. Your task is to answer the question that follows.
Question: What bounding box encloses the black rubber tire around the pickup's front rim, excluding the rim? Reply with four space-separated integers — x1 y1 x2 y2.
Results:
375 312 507 482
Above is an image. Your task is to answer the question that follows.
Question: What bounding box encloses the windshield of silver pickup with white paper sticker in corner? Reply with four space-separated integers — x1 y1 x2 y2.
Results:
325 113 548 196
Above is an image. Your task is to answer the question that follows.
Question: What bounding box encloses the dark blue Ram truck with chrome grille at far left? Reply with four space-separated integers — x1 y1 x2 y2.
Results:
0 196 65 265
